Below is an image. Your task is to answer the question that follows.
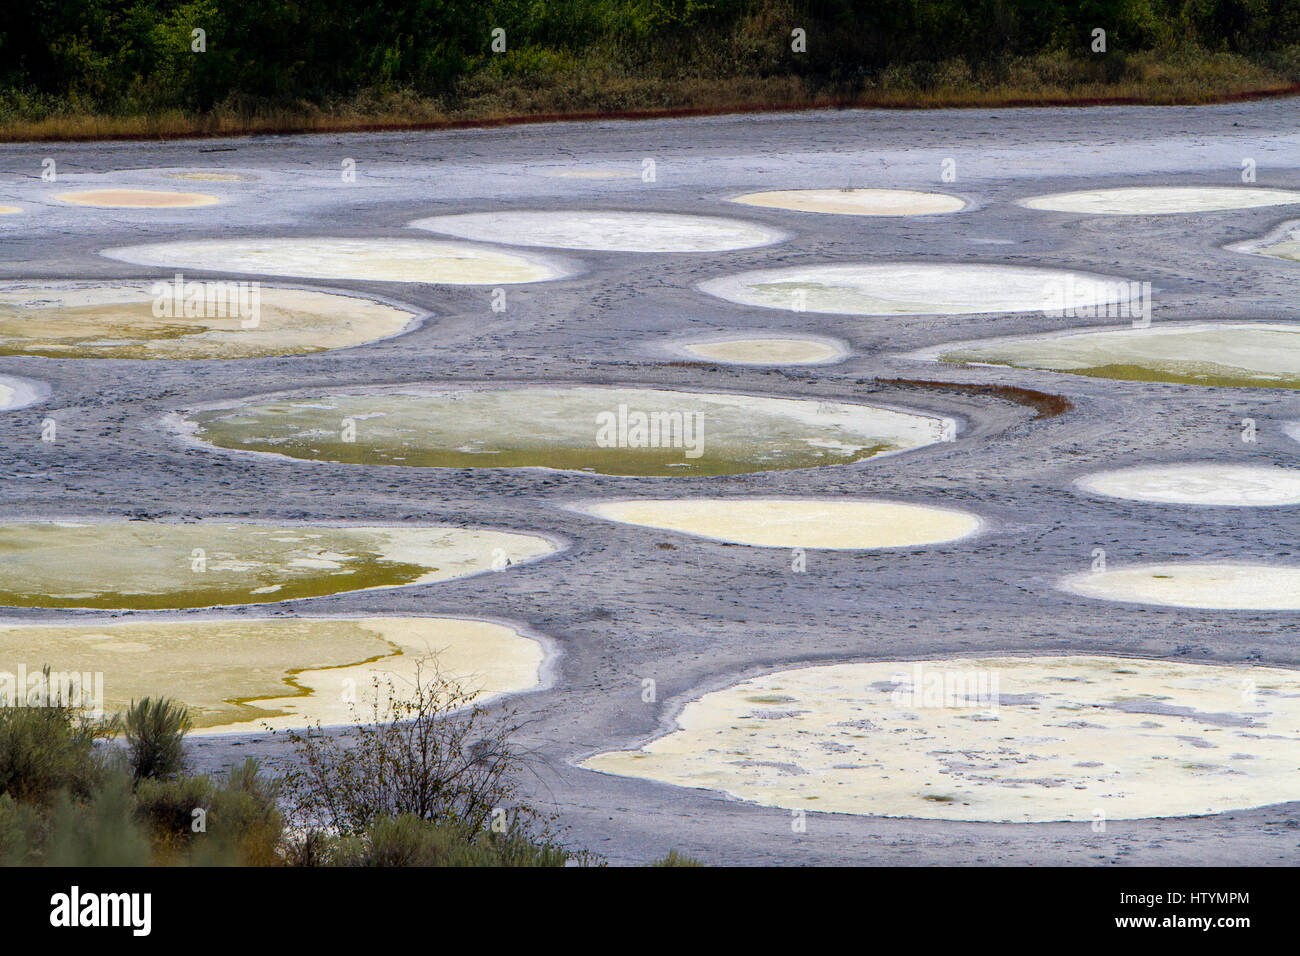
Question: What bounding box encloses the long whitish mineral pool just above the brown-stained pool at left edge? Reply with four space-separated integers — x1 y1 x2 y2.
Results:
109 237 572 285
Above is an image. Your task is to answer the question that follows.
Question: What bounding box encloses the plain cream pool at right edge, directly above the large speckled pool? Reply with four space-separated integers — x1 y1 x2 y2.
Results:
1058 562 1300 611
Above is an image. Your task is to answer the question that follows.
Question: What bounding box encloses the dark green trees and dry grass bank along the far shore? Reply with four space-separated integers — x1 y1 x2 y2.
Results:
0 0 1300 138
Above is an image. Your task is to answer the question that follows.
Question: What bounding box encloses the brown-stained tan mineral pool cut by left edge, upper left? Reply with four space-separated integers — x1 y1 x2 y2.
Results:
0 280 417 359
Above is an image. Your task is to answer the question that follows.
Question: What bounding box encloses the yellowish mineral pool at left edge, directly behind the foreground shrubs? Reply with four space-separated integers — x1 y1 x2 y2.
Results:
0 617 545 734
